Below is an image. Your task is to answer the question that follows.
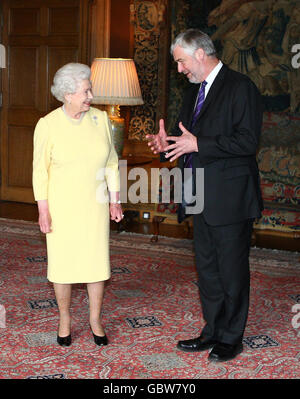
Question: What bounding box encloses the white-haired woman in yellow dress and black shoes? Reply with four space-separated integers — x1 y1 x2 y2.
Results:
33 63 123 346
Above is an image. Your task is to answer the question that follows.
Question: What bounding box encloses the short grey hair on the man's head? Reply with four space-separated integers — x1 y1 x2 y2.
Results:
170 29 217 56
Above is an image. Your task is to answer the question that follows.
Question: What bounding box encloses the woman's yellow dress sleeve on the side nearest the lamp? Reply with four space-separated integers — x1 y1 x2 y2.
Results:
104 112 120 192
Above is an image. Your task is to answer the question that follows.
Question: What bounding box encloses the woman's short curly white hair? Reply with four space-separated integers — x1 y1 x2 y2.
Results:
51 62 91 102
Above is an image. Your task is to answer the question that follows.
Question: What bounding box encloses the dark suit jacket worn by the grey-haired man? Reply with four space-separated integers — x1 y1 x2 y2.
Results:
168 65 263 226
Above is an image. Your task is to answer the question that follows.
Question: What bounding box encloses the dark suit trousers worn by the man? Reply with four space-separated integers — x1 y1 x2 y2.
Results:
194 214 253 344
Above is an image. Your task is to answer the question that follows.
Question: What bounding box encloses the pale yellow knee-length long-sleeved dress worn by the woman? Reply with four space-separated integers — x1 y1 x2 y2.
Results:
33 107 120 284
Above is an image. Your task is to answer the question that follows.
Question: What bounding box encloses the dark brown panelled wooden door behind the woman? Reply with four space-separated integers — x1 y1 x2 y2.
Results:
0 0 91 203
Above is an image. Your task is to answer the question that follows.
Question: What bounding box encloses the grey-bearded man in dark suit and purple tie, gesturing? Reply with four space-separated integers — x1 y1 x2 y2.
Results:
147 29 263 361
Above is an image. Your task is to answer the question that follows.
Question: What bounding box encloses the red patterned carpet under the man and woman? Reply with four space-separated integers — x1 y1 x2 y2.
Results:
0 219 300 380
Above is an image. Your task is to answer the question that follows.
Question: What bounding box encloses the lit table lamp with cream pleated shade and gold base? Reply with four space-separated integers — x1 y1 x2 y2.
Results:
91 58 144 157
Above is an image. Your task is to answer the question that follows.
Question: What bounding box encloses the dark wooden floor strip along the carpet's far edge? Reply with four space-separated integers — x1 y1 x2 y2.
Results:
0 201 300 251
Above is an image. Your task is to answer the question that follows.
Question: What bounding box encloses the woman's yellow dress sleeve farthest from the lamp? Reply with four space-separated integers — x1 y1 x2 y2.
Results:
32 118 51 201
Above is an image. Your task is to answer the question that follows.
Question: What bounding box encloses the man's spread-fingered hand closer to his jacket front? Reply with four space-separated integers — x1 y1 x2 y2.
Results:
164 122 198 162
